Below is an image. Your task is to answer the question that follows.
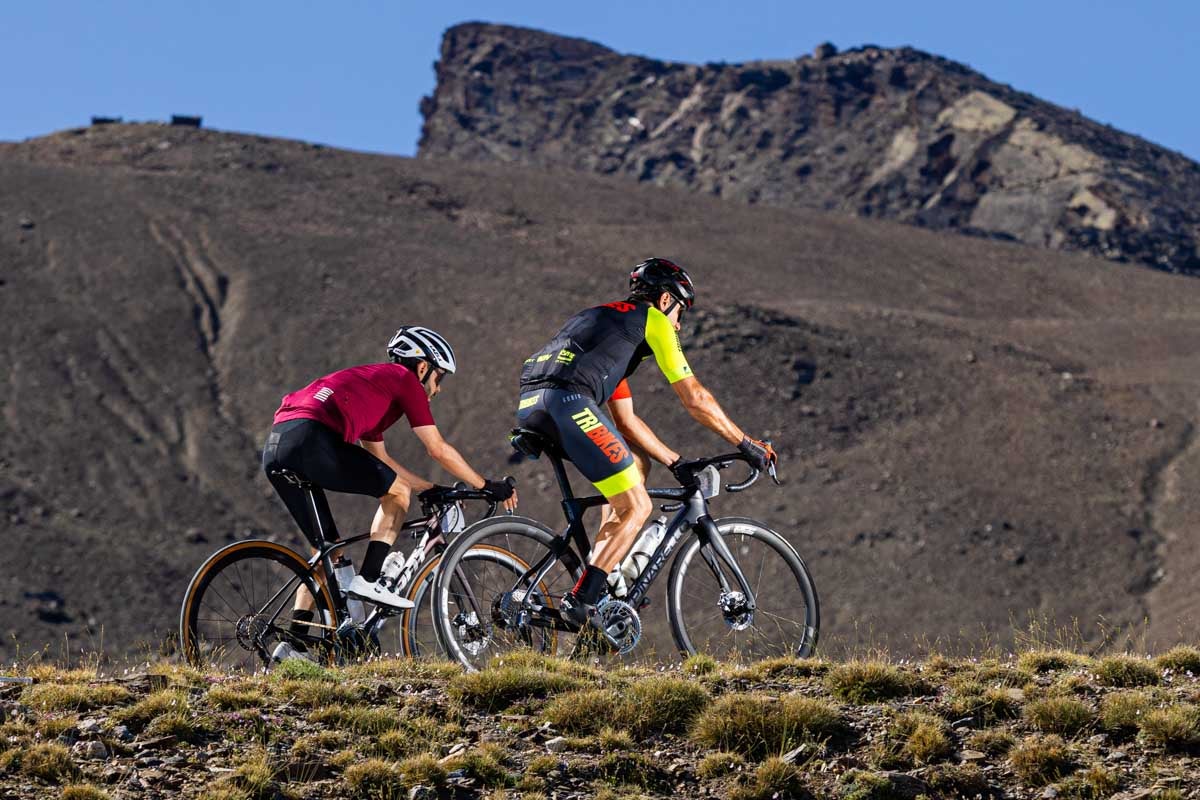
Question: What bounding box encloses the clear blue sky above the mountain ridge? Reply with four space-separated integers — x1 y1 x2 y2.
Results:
0 0 1200 160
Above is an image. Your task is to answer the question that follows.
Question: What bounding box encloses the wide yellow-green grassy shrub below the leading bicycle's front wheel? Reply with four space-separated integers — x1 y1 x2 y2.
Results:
691 694 846 760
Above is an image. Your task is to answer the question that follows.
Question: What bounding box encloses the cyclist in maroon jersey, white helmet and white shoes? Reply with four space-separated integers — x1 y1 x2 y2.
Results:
263 325 517 628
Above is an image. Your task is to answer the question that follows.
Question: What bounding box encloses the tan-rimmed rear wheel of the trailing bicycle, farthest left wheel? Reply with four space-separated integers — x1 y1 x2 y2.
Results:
179 540 335 672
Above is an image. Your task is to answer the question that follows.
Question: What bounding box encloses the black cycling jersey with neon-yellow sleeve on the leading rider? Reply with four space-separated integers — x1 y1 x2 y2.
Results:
521 301 691 403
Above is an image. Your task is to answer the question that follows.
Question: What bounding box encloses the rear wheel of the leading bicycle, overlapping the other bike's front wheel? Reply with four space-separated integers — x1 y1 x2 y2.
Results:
433 517 582 670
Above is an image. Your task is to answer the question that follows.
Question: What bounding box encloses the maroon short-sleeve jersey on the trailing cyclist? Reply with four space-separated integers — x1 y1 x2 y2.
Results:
275 363 433 443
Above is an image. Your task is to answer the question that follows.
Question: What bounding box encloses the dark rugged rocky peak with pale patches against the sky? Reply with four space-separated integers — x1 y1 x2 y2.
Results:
420 23 1200 275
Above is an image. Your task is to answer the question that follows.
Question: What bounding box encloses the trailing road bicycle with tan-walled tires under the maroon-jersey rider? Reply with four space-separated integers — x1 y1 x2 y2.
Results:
179 470 527 672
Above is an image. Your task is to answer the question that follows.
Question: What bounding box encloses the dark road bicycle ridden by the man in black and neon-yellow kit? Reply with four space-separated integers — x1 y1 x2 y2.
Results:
433 428 820 669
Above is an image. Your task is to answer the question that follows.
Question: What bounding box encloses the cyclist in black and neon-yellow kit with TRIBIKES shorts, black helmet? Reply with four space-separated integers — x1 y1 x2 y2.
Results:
517 258 775 625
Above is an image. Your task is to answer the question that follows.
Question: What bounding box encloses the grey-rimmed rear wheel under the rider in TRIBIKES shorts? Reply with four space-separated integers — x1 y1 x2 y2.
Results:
433 516 582 672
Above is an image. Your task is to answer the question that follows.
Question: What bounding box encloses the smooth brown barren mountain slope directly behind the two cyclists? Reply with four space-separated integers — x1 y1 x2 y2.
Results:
0 123 1200 661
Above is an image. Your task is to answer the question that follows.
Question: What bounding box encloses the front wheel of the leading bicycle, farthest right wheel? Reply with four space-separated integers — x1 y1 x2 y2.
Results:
667 517 821 662
